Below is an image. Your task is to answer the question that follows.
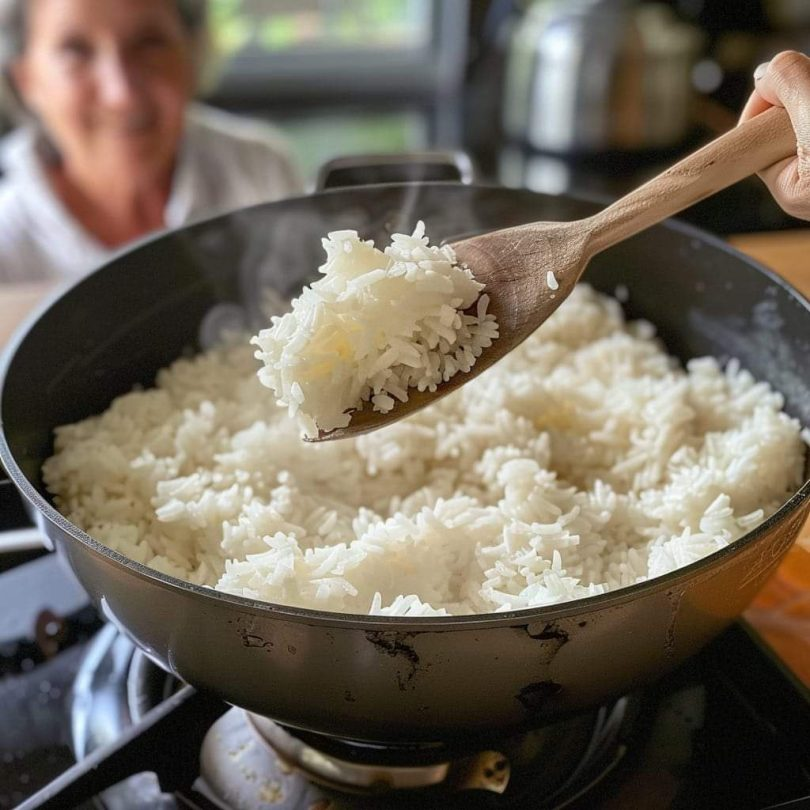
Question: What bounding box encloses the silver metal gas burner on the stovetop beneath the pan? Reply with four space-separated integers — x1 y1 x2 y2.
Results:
72 625 641 810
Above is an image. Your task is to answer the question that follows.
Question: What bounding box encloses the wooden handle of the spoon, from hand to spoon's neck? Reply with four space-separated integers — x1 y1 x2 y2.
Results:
585 107 796 256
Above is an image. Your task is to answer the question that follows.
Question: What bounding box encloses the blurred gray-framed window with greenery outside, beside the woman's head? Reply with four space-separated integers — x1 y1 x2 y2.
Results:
209 0 468 180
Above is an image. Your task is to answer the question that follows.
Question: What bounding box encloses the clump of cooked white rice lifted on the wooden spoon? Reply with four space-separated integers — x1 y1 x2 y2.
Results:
252 222 498 436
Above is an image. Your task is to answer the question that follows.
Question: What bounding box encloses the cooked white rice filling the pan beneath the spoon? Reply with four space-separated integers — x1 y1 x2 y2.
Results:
44 286 804 616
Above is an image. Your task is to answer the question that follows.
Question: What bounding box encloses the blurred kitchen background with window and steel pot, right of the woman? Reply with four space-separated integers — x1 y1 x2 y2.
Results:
7 0 810 234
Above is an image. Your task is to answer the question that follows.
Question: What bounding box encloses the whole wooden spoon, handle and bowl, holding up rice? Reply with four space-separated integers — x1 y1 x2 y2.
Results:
308 107 796 441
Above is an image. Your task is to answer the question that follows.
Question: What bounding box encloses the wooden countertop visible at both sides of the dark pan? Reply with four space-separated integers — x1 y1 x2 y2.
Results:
0 229 810 686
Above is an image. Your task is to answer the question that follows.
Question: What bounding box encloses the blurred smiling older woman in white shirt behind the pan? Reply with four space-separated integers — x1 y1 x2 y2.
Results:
0 0 300 283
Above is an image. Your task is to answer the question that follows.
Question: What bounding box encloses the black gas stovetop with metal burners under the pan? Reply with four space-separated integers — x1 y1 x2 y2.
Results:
0 476 810 810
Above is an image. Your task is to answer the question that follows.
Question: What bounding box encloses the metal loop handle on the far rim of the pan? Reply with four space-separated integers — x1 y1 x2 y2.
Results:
315 151 475 191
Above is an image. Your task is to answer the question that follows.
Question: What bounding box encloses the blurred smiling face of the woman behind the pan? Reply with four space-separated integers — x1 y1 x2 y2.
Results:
14 0 194 182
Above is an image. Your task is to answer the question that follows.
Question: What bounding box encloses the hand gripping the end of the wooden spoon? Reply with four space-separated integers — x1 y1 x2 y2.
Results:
740 51 810 220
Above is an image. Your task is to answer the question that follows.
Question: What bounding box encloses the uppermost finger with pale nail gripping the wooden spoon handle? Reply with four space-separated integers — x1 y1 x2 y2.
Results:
756 51 810 170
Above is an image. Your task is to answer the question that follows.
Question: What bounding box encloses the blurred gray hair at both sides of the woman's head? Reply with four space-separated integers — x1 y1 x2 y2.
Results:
0 0 209 119
